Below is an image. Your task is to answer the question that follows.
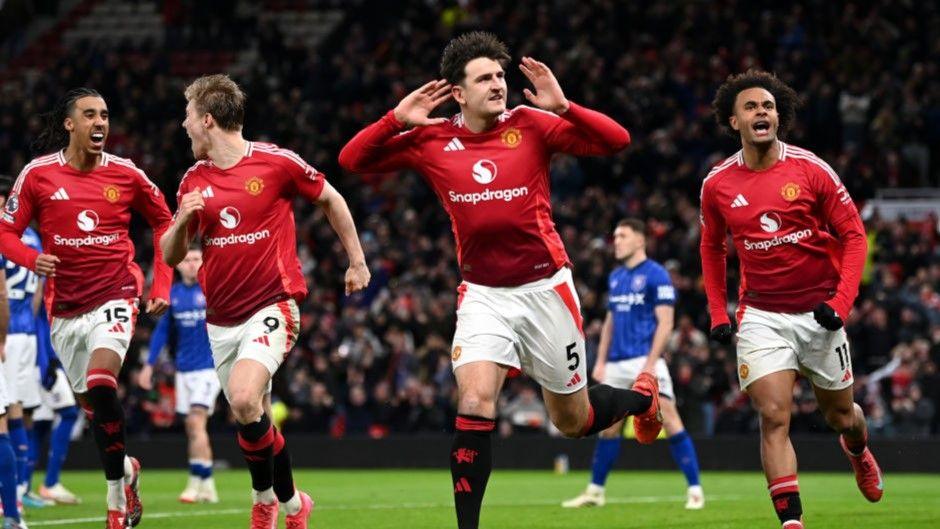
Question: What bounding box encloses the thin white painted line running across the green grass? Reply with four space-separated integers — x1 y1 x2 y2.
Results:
29 495 745 527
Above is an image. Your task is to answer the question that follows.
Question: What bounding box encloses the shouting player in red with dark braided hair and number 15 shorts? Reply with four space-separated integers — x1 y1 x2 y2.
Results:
0 88 172 528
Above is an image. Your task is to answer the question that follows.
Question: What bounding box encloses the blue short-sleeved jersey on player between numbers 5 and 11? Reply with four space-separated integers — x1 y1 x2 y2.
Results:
607 259 676 362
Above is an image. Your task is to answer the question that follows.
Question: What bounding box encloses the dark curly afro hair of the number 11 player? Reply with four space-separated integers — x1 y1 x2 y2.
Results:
712 69 801 138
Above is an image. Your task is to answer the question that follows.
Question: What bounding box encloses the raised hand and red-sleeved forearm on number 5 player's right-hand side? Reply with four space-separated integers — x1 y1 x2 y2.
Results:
519 57 630 156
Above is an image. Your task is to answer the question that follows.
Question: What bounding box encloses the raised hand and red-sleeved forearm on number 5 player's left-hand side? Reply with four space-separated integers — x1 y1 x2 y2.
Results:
339 80 451 173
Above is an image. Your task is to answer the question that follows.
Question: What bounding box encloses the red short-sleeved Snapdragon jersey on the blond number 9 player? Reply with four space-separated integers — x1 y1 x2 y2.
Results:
176 142 325 326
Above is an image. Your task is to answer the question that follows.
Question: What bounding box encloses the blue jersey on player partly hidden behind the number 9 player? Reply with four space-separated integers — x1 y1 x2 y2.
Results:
147 282 214 373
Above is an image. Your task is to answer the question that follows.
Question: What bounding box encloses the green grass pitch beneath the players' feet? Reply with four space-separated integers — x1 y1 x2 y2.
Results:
26 467 940 529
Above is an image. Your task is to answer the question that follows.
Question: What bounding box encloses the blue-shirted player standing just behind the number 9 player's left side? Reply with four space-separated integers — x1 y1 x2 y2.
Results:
138 249 222 503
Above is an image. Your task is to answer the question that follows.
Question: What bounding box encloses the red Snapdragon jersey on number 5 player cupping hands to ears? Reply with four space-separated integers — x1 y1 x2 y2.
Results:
339 103 630 287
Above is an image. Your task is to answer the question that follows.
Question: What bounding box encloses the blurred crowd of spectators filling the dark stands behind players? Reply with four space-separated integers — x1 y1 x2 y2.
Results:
0 0 940 436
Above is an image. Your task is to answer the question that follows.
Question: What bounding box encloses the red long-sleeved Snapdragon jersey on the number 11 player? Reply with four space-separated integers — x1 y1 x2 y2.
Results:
701 142 867 327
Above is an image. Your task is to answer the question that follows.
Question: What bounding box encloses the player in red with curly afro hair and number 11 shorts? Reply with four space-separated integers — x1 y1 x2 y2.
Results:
701 70 884 529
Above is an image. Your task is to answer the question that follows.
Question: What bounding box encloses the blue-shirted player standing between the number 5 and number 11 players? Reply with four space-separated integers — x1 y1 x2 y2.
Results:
562 219 705 509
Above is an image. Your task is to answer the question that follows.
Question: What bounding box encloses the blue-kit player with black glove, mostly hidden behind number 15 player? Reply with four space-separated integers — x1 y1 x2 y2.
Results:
24 300 81 505
